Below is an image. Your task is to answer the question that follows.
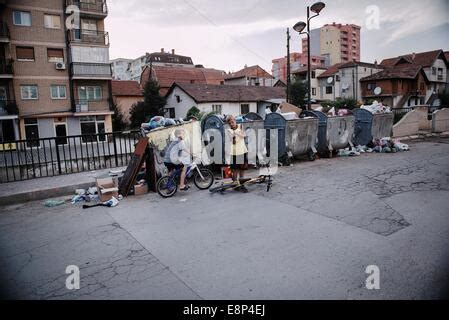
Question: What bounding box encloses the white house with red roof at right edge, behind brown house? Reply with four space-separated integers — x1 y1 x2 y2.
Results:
381 50 449 106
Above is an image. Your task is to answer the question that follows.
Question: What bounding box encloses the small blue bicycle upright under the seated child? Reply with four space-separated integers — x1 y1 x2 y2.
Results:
156 163 214 198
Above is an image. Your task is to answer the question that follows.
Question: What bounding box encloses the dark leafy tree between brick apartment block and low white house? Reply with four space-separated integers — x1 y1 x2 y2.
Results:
129 80 166 128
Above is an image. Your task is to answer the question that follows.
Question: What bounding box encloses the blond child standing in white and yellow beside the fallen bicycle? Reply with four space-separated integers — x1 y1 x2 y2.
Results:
225 115 248 193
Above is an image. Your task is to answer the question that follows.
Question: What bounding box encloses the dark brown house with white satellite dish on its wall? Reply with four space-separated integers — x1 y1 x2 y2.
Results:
360 62 430 108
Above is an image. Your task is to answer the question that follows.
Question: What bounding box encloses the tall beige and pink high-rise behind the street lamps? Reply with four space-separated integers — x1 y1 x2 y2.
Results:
302 22 361 66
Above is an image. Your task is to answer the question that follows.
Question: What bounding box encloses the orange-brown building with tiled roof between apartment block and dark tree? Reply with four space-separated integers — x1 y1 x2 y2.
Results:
112 80 143 124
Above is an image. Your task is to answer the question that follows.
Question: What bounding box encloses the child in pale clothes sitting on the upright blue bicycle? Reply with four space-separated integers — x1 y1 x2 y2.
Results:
164 129 191 191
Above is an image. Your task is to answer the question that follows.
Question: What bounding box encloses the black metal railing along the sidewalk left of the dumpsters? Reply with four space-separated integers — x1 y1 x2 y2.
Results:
0 131 141 183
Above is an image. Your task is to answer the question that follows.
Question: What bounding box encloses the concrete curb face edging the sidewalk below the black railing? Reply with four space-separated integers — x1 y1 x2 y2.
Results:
0 182 92 206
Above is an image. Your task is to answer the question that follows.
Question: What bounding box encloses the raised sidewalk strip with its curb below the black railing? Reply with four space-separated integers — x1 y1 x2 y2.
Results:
0 167 126 206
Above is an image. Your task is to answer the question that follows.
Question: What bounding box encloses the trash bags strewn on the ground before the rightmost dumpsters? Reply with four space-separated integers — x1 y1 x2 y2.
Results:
337 137 410 157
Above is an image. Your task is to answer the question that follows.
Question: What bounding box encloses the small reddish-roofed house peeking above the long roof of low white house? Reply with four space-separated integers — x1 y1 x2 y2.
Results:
225 66 275 87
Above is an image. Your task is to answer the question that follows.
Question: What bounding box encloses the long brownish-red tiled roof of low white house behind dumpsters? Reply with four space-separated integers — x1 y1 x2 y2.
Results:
167 83 286 103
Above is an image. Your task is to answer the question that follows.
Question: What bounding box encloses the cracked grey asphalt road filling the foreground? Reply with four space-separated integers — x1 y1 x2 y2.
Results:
0 138 449 299
